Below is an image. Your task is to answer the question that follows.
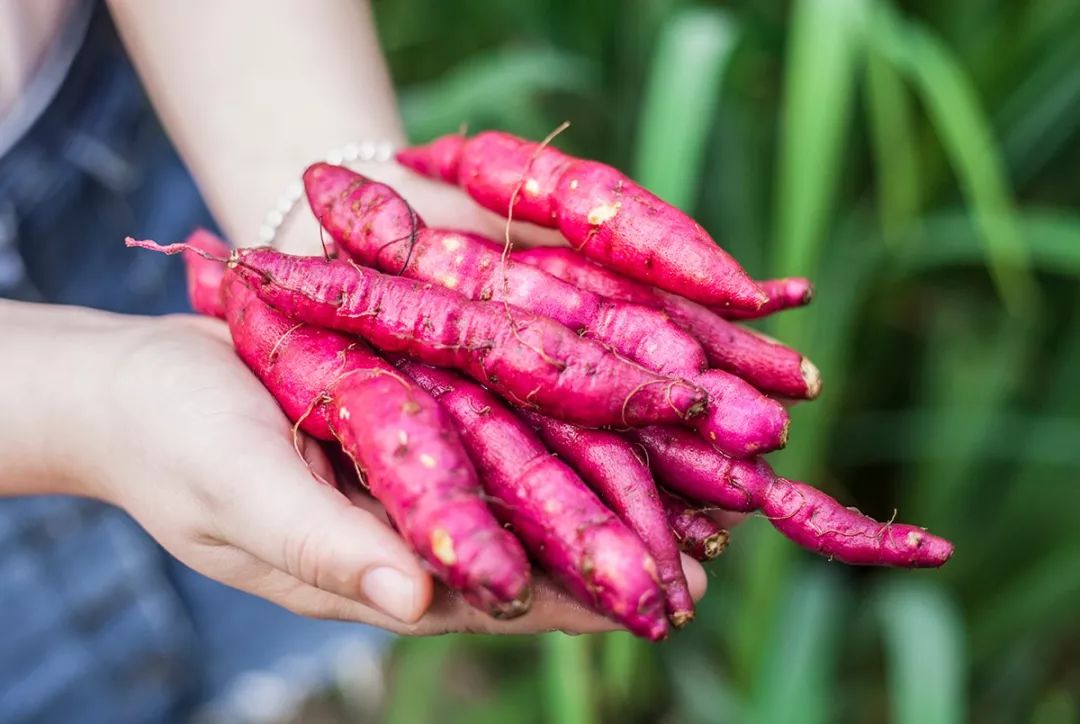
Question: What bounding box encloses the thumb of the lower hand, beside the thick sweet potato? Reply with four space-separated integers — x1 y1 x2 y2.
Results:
208 438 432 624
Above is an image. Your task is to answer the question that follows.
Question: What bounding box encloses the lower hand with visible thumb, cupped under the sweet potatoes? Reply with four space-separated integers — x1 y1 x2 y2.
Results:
65 317 705 634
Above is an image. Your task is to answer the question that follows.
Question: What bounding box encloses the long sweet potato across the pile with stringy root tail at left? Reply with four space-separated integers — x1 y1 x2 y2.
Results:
127 239 707 426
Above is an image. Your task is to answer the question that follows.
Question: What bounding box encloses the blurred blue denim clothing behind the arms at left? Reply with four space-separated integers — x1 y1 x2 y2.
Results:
0 8 383 724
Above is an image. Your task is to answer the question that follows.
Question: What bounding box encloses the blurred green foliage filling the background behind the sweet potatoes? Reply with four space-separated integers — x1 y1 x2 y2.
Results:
376 0 1080 724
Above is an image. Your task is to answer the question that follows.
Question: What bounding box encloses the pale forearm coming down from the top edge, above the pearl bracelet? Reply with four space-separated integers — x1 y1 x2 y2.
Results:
110 0 403 250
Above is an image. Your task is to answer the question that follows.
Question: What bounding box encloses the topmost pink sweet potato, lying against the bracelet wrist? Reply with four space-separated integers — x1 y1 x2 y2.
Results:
397 132 768 311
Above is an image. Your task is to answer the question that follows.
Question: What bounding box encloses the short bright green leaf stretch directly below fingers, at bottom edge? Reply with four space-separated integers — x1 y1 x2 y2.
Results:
541 633 595 724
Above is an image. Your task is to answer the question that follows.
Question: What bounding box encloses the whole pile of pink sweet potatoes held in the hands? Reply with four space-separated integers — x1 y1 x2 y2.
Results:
129 132 953 640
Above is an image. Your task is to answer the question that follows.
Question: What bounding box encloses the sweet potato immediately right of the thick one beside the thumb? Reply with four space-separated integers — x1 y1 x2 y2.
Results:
397 360 667 641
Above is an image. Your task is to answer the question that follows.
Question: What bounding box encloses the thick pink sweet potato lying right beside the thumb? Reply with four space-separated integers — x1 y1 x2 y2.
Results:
224 272 530 618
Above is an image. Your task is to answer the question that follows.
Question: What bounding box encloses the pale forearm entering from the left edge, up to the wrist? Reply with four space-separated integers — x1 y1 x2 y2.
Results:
0 299 124 496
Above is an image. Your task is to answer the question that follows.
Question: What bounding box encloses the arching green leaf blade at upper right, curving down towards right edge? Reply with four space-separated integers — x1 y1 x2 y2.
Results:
876 9 1037 314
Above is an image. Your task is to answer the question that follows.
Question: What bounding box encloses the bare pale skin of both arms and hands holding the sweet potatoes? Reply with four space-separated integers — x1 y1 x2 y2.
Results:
0 0 725 634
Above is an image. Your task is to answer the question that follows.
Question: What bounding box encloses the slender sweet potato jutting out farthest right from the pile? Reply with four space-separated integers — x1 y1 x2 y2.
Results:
633 427 953 568
